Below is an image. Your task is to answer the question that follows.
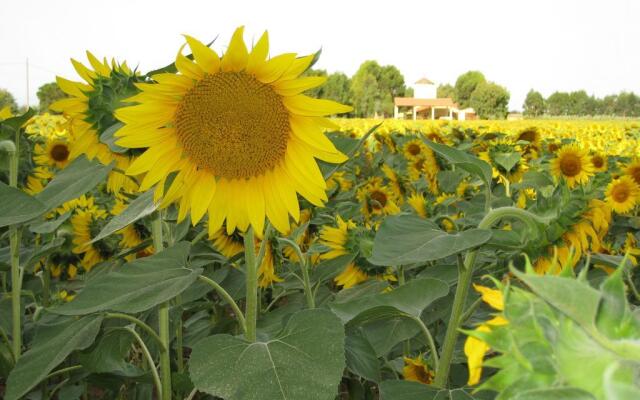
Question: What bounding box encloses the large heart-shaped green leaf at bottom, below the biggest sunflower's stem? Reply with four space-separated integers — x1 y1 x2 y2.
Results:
189 309 345 400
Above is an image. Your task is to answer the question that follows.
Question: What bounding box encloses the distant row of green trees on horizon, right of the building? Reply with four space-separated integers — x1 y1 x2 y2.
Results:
523 89 640 117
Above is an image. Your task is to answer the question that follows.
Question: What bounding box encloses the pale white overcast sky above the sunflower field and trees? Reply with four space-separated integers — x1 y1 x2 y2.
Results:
0 0 640 110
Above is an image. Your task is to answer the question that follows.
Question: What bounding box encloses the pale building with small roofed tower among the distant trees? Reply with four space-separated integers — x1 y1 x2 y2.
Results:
393 78 476 120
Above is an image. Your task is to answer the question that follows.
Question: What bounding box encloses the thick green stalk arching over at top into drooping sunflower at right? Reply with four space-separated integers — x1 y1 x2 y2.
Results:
434 207 544 387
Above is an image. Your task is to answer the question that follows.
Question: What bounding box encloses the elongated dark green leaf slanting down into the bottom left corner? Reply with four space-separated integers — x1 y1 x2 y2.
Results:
5 315 102 400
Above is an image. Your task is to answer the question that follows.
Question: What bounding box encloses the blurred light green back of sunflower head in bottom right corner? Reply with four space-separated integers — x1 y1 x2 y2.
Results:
471 267 640 399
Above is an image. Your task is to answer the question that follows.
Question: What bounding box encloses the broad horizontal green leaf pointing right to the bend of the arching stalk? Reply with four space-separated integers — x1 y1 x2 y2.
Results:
369 214 491 266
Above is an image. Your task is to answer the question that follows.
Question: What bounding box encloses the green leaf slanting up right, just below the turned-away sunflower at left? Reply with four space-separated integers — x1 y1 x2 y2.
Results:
36 156 113 209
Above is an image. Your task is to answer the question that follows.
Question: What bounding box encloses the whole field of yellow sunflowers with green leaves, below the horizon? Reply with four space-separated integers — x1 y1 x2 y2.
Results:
0 28 640 400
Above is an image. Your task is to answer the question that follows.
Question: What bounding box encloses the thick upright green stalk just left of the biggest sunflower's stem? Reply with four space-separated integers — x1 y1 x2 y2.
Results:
151 211 171 399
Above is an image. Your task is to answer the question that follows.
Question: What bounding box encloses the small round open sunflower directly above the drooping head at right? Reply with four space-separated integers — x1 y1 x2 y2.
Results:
551 144 594 188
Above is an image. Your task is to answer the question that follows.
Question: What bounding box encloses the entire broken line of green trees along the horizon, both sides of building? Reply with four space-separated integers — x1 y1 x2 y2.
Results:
0 60 640 119
